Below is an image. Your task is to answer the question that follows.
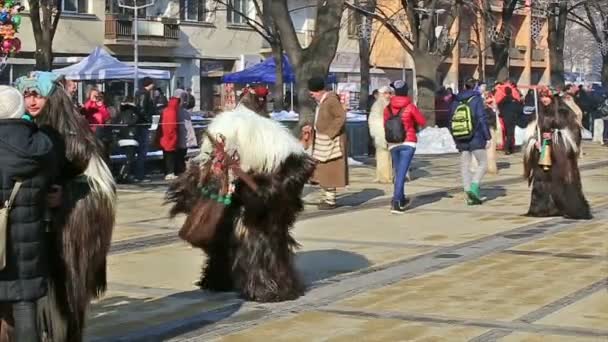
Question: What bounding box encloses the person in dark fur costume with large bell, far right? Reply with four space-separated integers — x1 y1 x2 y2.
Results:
524 87 592 219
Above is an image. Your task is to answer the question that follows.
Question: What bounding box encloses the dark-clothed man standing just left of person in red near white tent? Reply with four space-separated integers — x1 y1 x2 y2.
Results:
135 77 157 182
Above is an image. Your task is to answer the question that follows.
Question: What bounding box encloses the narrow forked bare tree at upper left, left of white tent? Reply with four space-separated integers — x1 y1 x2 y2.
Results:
29 0 63 71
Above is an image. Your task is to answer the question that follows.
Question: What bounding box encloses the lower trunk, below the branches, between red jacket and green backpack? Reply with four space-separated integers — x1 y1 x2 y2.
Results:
414 51 441 127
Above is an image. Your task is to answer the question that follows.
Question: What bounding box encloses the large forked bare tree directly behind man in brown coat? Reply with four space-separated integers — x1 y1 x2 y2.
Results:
270 0 344 125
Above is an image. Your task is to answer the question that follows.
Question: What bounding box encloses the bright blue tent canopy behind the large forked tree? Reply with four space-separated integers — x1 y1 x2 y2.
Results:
222 55 336 84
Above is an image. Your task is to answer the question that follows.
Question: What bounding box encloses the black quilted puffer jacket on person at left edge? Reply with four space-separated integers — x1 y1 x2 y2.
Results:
0 119 57 302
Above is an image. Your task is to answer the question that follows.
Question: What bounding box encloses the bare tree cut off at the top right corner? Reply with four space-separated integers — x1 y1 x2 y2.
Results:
570 0 608 87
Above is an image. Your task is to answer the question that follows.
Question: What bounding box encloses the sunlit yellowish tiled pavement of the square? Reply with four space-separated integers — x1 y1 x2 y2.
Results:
87 145 608 341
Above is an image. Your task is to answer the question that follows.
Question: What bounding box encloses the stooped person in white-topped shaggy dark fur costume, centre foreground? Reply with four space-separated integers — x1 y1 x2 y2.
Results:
167 106 315 302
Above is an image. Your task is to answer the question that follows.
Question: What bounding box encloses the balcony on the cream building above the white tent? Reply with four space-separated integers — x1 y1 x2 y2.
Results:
105 14 180 47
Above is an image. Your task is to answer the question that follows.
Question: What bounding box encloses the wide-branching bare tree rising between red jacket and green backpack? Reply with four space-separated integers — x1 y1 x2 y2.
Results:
346 0 465 126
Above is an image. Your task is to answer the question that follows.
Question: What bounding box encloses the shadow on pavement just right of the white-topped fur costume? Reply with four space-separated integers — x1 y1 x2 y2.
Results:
296 249 371 286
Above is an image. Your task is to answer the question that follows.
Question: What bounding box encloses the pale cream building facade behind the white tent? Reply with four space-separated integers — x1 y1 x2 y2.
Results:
0 0 372 111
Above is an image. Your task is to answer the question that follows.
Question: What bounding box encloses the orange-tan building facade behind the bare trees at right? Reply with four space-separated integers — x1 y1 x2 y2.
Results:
372 0 550 89
